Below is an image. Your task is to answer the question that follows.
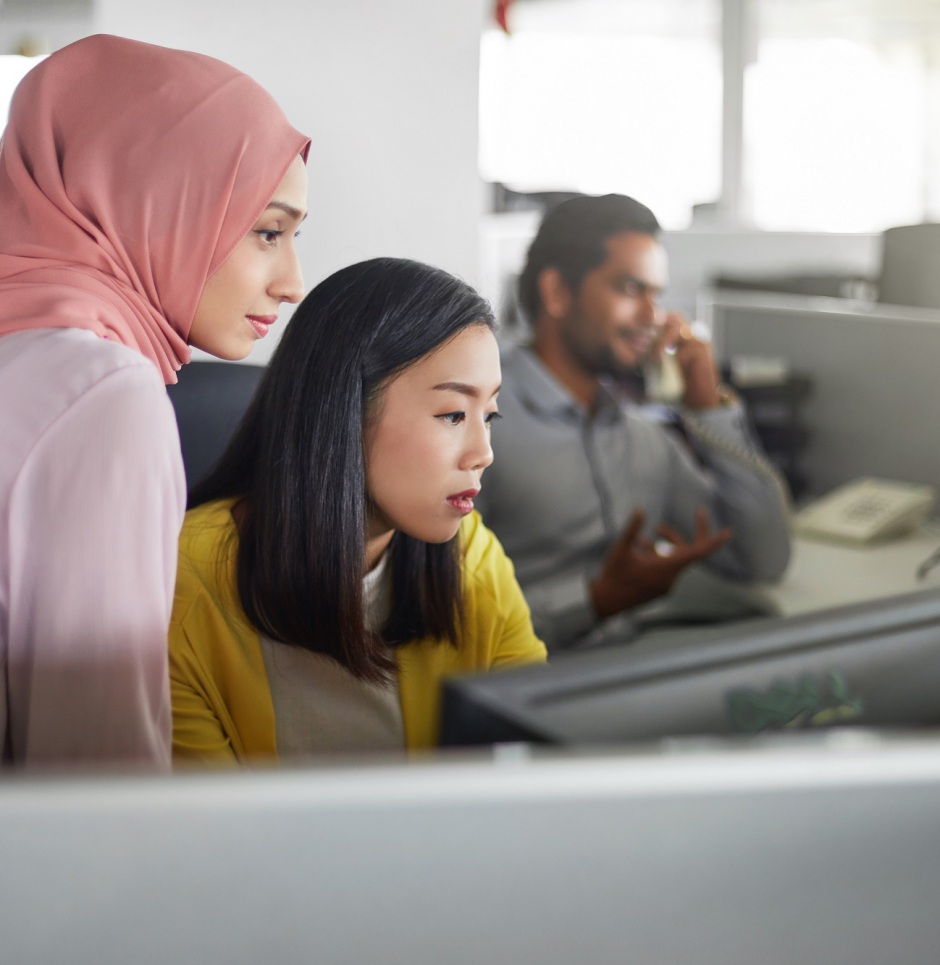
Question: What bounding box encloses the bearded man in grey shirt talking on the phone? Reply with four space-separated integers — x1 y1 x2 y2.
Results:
477 194 790 650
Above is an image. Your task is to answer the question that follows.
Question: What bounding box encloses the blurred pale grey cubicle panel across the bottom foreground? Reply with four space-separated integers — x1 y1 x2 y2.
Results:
0 734 940 965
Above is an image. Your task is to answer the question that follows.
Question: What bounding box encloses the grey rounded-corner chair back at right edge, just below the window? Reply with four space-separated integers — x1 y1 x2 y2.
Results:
878 223 940 309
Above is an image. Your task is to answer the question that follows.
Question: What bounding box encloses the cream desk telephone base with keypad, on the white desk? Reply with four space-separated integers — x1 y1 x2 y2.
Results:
793 478 934 543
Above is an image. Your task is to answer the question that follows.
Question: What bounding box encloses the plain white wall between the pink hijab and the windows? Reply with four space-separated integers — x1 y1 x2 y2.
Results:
95 0 484 362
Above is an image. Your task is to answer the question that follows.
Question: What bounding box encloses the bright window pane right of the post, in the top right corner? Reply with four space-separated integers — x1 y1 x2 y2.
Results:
744 0 940 231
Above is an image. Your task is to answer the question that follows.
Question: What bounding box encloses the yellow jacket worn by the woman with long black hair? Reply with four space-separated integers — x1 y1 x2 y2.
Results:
170 500 546 764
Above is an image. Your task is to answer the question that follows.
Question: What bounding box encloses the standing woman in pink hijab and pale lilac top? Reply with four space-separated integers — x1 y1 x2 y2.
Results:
0 36 309 768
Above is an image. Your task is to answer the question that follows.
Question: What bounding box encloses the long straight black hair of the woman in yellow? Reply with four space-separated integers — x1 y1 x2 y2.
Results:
190 252 494 681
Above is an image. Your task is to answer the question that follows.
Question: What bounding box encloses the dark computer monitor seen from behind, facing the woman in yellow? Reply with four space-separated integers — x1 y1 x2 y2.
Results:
441 589 940 746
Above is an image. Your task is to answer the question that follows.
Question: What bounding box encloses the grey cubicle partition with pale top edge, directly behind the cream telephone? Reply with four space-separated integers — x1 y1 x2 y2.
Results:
700 288 940 493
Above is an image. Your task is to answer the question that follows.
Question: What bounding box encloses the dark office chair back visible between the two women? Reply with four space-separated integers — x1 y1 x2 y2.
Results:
167 361 264 498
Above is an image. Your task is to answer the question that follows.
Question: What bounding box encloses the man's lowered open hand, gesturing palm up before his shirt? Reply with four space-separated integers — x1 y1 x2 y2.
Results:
589 509 732 618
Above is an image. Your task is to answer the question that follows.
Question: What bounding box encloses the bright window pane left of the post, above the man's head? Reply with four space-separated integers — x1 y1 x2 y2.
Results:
480 0 721 228
